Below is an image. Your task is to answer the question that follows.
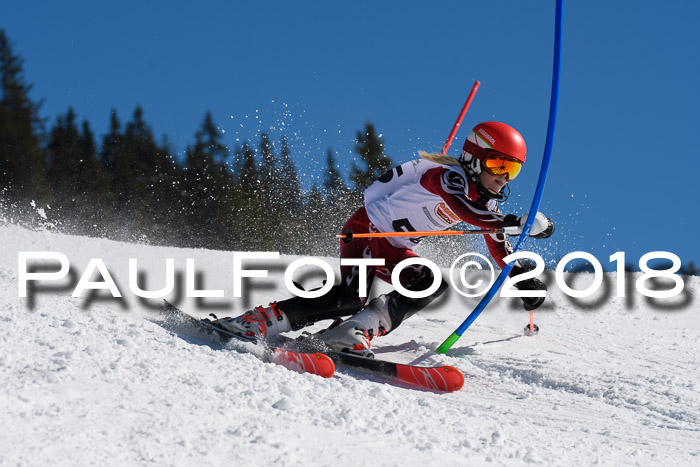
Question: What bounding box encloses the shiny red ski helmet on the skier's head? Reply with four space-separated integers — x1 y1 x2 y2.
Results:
462 122 527 162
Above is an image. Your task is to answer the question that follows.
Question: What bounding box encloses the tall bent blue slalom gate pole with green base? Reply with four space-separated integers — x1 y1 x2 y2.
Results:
437 0 563 353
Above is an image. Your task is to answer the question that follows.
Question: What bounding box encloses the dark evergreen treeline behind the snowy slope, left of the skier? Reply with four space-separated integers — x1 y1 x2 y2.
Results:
0 29 392 255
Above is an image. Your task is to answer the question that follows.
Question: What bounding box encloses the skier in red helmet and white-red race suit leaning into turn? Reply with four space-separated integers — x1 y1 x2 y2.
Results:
215 122 554 357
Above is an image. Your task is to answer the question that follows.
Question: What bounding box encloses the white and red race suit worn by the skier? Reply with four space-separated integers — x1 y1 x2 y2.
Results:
340 159 513 300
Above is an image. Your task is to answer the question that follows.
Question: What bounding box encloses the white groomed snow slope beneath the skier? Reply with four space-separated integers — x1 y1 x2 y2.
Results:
0 225 700 466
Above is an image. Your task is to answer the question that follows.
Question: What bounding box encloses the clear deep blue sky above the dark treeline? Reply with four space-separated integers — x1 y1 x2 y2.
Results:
0 0 700 269
